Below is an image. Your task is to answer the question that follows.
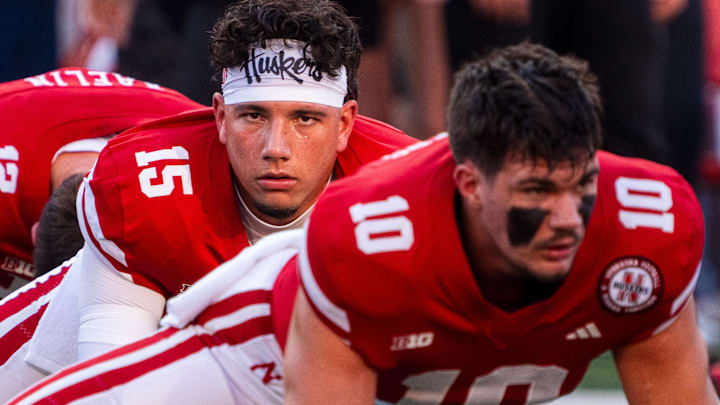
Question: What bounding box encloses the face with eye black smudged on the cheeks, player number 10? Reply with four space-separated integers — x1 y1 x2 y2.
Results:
470 154 599 281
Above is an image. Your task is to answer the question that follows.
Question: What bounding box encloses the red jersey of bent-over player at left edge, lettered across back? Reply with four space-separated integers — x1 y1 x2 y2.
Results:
0 68 203 286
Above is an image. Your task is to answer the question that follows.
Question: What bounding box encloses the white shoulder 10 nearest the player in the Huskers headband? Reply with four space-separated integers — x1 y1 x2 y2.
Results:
350 195 415 255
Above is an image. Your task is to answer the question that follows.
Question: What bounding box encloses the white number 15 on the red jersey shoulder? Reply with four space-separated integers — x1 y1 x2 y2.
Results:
135 146 193 198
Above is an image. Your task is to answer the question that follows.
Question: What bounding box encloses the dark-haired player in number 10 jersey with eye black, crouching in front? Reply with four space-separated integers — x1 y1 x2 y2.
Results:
284 44 718 405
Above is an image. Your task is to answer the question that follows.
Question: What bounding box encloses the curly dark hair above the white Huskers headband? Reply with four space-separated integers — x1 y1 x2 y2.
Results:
210 0 362 101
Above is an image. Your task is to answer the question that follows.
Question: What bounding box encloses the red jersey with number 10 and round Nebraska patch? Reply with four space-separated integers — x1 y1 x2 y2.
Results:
299 137 704 404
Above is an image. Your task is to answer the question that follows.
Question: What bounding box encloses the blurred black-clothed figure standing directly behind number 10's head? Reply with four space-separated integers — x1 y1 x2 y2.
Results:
531 0 670 164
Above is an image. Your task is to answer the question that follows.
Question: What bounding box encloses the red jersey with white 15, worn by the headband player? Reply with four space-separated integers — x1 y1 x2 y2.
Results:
81 109 415 297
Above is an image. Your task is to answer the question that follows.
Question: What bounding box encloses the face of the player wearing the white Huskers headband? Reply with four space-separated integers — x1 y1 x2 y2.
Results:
213 94 357 225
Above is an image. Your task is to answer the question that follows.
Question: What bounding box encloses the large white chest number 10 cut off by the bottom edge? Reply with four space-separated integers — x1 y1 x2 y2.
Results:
398 364 568 405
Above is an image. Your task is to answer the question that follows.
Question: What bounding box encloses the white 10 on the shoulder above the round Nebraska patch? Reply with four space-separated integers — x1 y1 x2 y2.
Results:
615 177 675 233
